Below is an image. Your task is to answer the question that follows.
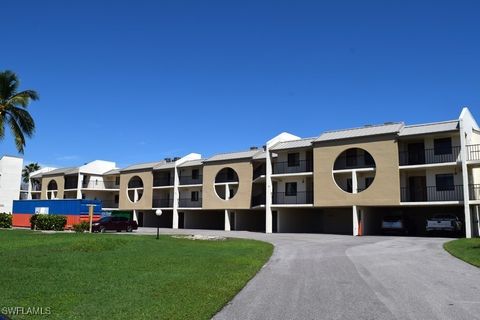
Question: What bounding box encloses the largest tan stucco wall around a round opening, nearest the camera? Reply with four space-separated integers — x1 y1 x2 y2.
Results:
313 137 400 207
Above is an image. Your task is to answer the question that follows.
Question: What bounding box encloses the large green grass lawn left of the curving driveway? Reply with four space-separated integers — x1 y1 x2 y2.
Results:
0 230 273 319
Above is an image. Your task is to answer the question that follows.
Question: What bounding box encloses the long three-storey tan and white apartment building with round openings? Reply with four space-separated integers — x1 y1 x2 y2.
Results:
24 108 480 237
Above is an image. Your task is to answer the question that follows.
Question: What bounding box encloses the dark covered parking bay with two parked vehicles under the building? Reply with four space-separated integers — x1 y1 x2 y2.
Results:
357 205 465 237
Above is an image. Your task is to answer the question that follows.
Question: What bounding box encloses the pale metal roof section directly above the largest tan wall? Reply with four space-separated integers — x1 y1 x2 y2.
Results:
315 122 404 142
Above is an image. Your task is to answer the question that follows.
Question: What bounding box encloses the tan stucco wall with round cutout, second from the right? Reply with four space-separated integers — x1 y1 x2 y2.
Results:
202 161 253 209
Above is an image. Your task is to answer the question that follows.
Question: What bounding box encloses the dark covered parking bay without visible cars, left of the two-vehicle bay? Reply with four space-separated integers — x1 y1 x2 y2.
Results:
273 207 353 235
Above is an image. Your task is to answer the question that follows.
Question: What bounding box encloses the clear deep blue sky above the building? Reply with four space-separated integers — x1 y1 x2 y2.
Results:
0 0 480 166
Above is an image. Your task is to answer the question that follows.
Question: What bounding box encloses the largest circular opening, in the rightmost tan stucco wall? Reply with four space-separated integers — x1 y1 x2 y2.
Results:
333 148 376 193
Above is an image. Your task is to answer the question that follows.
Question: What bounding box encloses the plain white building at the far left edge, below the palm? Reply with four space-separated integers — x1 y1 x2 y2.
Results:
0 155 23 213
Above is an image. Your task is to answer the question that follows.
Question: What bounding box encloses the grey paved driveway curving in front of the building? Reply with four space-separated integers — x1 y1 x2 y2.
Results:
136 229 480 320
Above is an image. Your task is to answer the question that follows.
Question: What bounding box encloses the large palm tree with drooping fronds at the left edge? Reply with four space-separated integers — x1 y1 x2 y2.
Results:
0 70 38 153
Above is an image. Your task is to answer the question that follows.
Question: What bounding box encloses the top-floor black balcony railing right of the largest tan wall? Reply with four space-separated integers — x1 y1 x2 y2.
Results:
399 147 460 166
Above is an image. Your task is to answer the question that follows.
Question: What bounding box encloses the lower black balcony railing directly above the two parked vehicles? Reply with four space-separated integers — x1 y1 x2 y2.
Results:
400 185 463 202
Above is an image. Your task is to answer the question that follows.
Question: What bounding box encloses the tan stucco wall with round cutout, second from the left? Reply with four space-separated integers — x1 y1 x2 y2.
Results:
119 171 153 210
